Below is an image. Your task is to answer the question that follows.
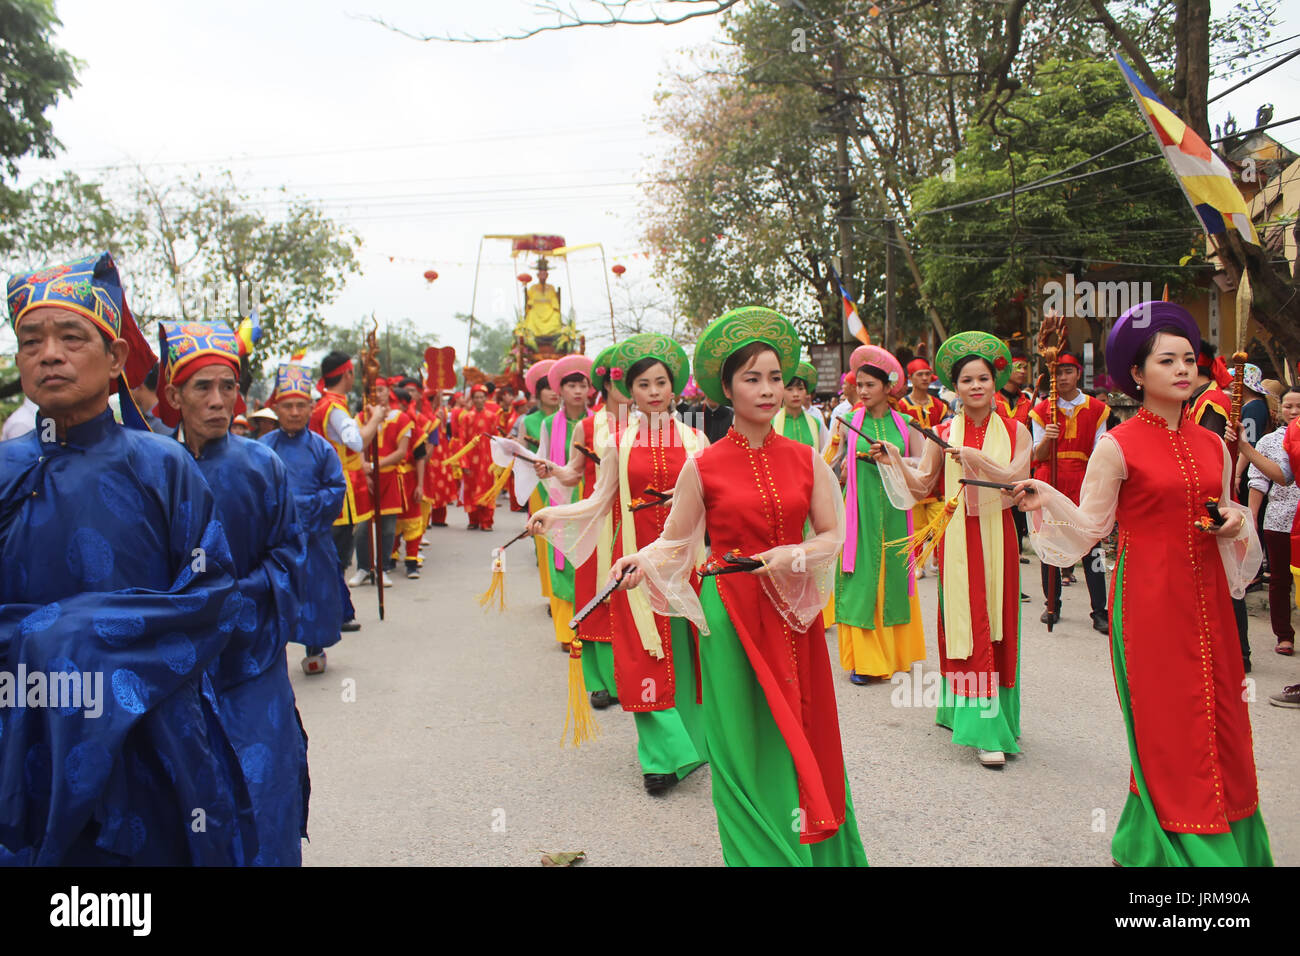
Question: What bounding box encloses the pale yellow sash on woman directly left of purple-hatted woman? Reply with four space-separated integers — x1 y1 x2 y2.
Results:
944 412 1015 661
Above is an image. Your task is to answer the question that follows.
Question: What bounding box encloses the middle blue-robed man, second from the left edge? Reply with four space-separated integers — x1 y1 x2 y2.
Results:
159 321 309 866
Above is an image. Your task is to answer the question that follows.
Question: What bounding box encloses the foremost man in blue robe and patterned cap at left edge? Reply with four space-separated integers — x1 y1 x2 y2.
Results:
0 254 256 866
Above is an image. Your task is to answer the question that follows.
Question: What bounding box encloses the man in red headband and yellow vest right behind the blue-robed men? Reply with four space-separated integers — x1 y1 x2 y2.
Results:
307 351 380 590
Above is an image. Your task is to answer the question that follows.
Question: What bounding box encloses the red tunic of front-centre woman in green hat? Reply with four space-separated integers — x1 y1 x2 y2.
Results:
696 428 845 843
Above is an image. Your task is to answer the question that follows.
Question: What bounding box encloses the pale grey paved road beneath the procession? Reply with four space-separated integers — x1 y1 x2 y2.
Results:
290 509 1300 866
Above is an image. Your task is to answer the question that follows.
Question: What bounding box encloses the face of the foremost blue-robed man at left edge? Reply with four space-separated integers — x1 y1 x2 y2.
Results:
18 307 130 420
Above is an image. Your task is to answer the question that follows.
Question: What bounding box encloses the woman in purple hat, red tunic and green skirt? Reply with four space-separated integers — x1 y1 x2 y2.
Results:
1017 302 1273 866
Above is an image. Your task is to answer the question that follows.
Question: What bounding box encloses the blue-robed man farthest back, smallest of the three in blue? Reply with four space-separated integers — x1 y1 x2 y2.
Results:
260 364 354 674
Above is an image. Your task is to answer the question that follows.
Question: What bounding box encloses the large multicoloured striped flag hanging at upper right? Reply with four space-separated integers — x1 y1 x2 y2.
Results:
1114 53 1260 246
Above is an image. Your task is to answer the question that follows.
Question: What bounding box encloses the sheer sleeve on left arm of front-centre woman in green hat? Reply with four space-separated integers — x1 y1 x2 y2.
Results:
634 458 709 633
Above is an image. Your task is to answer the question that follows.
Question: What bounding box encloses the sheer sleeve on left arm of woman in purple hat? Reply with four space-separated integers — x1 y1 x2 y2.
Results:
1026 436 1128 567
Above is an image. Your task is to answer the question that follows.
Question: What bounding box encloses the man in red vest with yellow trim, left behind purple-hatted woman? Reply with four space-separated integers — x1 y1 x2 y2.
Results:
1030 352 1110 633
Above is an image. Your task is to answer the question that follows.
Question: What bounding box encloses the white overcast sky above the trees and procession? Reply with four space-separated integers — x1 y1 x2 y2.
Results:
5 0 1300 364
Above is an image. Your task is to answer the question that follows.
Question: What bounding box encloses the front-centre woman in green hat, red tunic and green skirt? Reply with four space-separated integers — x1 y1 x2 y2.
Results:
610 307 867 866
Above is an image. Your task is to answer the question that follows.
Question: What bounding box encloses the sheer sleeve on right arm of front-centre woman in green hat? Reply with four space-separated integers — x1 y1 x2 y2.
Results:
754 449 845 631
